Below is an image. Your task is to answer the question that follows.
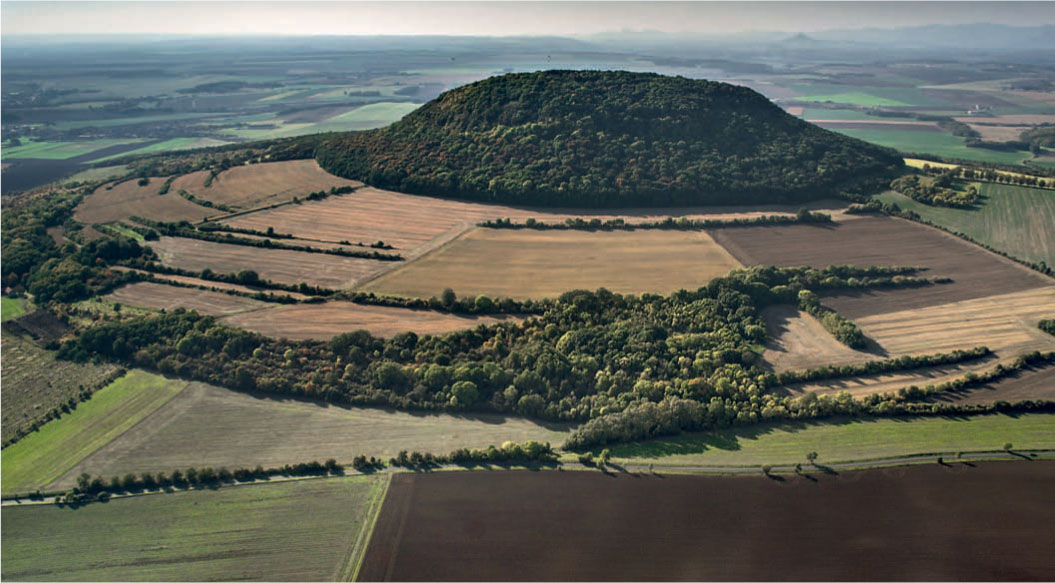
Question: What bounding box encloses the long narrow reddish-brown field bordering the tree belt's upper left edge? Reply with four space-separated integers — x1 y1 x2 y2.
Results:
224 302 519 341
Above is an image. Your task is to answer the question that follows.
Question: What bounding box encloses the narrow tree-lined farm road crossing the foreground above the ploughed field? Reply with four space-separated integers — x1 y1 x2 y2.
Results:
0 449 1055 506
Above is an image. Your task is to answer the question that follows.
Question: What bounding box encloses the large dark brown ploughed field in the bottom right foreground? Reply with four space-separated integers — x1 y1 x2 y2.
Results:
359 462 1055 581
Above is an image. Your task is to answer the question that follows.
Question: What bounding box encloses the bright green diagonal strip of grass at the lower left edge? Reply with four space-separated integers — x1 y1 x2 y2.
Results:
0 370 187 493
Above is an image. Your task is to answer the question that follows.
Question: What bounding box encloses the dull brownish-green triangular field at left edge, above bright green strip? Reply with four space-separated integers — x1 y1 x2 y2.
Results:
0 330 118 441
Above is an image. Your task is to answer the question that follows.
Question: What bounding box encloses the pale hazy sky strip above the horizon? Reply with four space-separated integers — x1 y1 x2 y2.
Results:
0 0 1055 36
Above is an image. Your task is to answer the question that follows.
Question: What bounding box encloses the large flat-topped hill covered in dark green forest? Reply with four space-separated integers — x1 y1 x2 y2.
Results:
317 71 902 207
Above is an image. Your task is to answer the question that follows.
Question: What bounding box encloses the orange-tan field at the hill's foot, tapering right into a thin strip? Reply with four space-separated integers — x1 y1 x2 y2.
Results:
225 188 846 257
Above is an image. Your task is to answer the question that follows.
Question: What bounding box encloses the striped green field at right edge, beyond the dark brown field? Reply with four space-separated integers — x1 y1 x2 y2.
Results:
879 182 1055 266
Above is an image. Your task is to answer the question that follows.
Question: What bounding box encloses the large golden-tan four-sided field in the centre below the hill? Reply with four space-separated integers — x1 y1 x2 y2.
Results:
363 229 740 298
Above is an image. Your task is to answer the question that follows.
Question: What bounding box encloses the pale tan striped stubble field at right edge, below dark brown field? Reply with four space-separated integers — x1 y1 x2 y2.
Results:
857 286 1055 357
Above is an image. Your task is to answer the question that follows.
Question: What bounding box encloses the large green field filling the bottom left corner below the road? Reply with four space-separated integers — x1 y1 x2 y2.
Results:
2 477 387 581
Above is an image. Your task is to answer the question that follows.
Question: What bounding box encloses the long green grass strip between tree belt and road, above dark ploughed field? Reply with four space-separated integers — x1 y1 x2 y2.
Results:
612 413 1055 466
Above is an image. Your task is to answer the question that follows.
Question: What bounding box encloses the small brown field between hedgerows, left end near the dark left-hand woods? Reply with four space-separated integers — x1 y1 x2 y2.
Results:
104 281 270 316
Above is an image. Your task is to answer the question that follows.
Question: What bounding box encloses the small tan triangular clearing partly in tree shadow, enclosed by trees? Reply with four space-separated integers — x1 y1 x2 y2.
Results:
762 306 877 372
